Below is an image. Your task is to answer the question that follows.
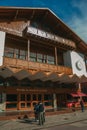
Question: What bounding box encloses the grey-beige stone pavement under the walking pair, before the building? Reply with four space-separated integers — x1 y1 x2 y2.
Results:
0 110 87 130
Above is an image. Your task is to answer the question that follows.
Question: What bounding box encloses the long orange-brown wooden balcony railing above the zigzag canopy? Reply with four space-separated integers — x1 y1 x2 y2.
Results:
3 57 72 74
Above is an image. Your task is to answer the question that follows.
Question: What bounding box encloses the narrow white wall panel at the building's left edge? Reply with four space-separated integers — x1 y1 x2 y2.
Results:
0 31 5 66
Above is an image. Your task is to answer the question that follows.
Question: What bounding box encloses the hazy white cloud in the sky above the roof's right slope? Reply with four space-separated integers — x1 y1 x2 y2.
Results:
68 0 87 42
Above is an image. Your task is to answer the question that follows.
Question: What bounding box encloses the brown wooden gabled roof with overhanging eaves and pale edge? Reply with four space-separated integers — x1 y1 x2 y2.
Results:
0 7 87 54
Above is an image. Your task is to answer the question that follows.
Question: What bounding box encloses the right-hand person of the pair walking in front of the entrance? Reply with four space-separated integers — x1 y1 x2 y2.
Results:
38 102 45 125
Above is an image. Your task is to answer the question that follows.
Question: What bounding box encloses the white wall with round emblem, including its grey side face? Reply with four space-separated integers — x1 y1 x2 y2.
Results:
64 51 87 76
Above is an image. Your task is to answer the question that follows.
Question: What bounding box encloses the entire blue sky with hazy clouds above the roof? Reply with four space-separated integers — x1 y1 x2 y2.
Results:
0 0 87 42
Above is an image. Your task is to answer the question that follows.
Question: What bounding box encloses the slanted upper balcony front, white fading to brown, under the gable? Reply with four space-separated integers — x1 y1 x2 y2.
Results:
24 26 76 49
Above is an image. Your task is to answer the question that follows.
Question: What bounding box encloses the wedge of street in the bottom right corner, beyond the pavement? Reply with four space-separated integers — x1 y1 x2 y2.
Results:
43 120 87 130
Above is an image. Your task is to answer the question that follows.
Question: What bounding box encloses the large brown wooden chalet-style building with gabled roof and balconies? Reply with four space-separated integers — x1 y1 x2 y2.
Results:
0 7 87 111
